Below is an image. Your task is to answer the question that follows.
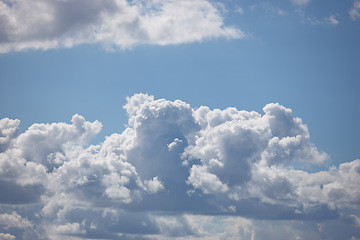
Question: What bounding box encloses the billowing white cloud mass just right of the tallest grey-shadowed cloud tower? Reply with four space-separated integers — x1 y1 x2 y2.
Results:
183 101 328 197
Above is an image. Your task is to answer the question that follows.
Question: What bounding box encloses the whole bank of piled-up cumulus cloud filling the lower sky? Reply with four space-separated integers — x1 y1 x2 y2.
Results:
0 94 360 239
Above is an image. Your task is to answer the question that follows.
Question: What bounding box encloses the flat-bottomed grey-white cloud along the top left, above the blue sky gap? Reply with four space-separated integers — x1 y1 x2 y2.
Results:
0 0 244 53
